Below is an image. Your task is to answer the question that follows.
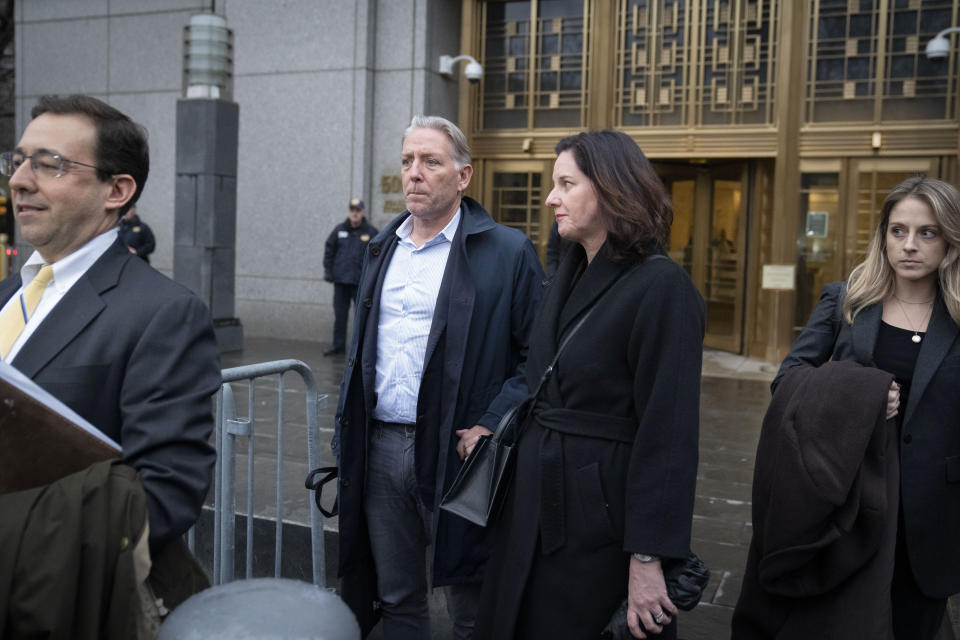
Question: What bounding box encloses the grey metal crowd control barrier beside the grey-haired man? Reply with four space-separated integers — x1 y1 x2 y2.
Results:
213 360 327 587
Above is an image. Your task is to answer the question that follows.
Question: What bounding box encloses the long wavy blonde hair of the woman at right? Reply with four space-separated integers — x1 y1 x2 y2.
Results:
843 176 960 325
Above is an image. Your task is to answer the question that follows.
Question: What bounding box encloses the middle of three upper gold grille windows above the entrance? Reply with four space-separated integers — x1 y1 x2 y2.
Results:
616 0 780 127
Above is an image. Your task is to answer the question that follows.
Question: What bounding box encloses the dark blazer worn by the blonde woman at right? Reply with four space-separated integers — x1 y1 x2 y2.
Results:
773 282 960 598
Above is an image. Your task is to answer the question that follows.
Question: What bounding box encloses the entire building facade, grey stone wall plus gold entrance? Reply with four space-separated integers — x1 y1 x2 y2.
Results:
16 0 960 361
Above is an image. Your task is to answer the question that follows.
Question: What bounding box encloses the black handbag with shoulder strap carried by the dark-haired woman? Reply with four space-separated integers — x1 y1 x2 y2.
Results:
440 307 593 527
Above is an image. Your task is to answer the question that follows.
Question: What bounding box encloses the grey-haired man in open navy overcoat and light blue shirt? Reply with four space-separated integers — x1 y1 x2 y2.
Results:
333 116 543 639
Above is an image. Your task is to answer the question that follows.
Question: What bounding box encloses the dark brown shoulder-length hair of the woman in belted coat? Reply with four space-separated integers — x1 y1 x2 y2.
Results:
555 130 673 262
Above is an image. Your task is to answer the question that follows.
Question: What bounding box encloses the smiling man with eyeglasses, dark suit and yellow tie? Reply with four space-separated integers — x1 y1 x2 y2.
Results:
0 95 220 552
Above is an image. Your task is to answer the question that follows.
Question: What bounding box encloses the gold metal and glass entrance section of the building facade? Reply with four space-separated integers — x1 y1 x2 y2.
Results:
460 0 960 361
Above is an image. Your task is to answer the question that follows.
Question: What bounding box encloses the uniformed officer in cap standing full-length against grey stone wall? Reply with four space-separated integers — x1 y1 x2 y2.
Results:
323 198 377 356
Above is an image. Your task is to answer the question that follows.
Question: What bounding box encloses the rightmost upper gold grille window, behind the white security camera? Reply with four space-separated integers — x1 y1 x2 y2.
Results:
805 0 960 123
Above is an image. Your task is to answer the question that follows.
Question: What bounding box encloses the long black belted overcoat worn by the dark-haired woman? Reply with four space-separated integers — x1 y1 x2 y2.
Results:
475 245 704 640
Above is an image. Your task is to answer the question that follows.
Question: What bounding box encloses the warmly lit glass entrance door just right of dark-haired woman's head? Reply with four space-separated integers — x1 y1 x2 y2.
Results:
656 162 749 353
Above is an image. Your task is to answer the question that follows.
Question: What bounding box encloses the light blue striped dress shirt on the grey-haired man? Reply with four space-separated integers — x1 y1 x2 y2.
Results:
373 209 460 424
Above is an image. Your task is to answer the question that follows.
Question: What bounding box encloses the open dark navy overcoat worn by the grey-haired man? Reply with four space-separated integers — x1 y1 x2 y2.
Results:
333 197 543 611
